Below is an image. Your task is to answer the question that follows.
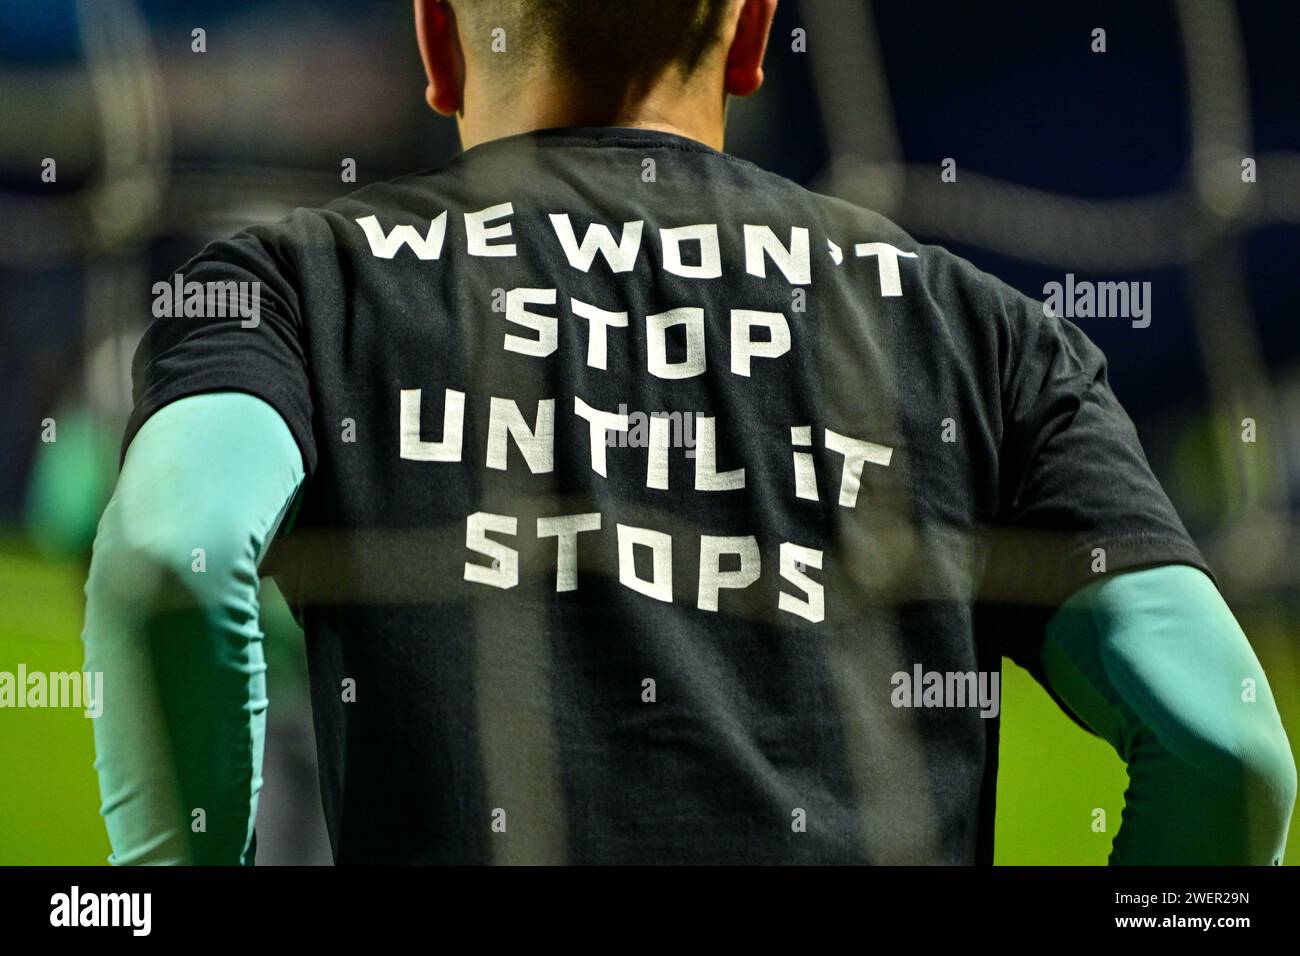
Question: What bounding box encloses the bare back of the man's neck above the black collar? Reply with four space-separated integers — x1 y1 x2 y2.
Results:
456 74 727 151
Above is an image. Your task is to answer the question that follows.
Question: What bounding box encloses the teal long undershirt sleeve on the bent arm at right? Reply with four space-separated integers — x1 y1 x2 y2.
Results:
1043 566 1296 865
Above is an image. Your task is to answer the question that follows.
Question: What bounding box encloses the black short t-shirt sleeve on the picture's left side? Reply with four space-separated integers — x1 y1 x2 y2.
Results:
122 228 316 475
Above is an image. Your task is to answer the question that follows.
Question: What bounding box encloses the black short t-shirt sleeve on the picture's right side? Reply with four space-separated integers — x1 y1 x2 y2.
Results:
991 289 1213 663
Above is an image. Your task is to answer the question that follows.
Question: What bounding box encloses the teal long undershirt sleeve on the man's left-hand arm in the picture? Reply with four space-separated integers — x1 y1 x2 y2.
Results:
82 393 303 864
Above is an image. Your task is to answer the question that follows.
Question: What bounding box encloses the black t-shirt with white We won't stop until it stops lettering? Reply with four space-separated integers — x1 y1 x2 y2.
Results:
126 129 1204 862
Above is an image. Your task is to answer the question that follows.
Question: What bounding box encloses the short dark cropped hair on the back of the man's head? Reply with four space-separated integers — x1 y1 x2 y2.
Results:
452 0 732 83
